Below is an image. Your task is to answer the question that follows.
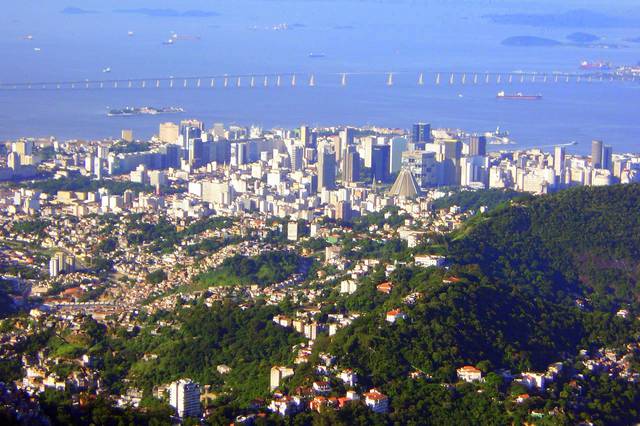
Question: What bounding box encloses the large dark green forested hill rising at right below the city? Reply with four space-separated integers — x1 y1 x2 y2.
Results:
328 185 640 423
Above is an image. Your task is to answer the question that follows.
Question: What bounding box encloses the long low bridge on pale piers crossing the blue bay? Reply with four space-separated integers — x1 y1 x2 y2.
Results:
0 71 640 90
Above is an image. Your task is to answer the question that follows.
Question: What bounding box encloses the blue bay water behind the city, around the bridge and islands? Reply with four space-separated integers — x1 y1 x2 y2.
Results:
0 0 640 152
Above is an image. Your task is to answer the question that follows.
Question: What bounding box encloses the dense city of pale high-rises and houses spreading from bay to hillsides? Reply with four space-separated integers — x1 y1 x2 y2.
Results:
0 120 640 424
